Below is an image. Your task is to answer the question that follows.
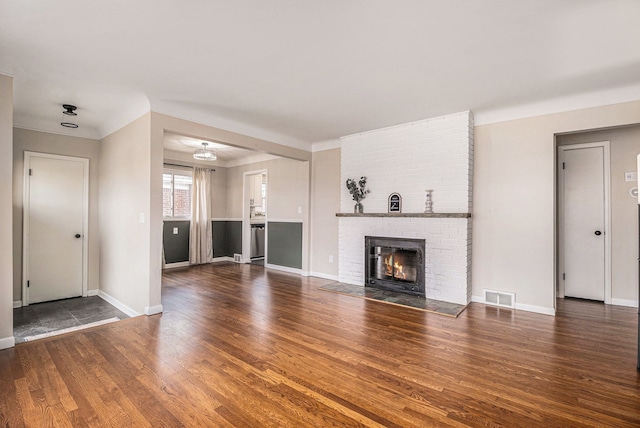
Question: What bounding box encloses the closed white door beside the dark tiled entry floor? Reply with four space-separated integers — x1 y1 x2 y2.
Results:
23 152 89 305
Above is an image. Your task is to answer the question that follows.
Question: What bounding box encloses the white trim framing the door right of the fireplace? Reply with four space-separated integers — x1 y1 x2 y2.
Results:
556 141 611 305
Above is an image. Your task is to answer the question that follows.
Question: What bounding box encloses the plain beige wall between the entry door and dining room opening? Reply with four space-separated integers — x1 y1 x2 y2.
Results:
99 114 154 314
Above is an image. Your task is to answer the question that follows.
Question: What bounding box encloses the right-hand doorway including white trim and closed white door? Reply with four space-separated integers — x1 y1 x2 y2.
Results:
557 141 611 304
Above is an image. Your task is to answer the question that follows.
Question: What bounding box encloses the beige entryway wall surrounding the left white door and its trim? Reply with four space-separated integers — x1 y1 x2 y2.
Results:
13 128 100 301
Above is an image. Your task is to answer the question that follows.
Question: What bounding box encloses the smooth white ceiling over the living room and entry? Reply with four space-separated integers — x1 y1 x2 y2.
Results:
0 0 640 150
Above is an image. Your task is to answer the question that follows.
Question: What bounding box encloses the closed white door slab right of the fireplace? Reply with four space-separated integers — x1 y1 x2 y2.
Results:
561 146 607 301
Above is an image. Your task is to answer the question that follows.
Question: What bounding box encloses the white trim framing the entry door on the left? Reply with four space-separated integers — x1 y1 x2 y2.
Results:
22 151 90 306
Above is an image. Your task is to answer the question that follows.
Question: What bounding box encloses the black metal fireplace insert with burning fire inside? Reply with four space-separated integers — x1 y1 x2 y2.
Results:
364 236 425 297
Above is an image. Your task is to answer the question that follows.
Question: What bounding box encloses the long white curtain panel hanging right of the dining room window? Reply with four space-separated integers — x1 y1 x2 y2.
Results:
189 167 213 264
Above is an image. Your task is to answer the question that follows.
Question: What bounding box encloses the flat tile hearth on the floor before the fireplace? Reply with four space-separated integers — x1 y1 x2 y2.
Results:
320 282 466 317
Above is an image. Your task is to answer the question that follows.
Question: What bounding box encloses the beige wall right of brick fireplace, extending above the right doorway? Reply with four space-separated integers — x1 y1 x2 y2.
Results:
472 101 640 313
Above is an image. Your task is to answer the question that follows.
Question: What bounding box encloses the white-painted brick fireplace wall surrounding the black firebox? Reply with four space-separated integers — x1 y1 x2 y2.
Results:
338 112 473 304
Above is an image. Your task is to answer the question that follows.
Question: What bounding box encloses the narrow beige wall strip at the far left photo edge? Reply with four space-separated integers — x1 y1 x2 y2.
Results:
0 74 15 349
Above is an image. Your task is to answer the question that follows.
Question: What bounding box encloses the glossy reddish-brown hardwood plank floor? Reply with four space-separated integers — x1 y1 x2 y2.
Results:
0 263 640 427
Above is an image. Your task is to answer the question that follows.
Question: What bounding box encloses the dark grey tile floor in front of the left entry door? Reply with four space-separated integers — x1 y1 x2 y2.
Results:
13 296 129 343
